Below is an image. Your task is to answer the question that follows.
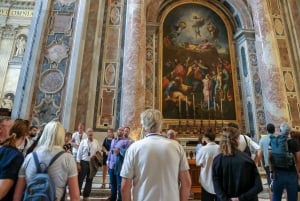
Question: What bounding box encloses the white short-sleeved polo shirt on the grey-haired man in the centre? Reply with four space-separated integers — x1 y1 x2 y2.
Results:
121 135 189 201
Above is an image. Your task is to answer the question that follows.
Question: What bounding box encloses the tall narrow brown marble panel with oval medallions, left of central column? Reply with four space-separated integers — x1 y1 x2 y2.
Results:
94 0 126 131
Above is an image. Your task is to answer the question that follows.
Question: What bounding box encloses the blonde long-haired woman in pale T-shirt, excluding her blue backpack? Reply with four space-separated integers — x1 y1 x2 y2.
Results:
14 121 80 201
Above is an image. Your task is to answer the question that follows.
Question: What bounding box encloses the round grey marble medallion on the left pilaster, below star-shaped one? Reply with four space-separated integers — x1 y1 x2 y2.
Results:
39 69 64 94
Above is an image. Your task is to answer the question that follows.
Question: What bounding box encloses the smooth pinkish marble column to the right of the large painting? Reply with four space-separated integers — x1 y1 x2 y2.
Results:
249 0 289 126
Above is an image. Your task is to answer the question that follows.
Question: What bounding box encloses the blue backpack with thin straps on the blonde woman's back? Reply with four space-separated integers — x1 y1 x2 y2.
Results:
23 151 65 201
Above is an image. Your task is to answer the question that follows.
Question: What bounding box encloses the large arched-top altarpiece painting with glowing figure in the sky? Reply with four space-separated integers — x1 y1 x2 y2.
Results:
159 2 237 127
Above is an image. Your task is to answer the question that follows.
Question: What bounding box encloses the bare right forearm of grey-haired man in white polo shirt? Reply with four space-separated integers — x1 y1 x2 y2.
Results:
179 170 192 201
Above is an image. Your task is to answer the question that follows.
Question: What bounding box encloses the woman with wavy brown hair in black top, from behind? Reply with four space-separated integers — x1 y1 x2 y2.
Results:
212 127 263 201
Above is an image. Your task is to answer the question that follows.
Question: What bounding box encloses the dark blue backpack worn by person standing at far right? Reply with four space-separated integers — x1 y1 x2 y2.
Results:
270 134 295 169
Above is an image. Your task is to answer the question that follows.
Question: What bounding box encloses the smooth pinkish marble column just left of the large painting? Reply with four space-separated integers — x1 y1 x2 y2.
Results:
120 0 146 135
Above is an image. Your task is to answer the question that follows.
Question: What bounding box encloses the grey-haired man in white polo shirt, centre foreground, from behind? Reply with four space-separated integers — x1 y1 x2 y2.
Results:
121 109 191 201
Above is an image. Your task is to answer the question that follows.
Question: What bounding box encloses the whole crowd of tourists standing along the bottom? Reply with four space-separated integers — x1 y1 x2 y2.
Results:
0 109 300 201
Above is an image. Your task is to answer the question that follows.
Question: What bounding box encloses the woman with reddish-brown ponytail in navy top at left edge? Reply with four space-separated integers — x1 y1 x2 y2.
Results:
0 120 28 201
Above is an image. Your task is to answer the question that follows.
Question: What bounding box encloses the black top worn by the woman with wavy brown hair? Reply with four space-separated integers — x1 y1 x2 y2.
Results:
212 150 263 201
